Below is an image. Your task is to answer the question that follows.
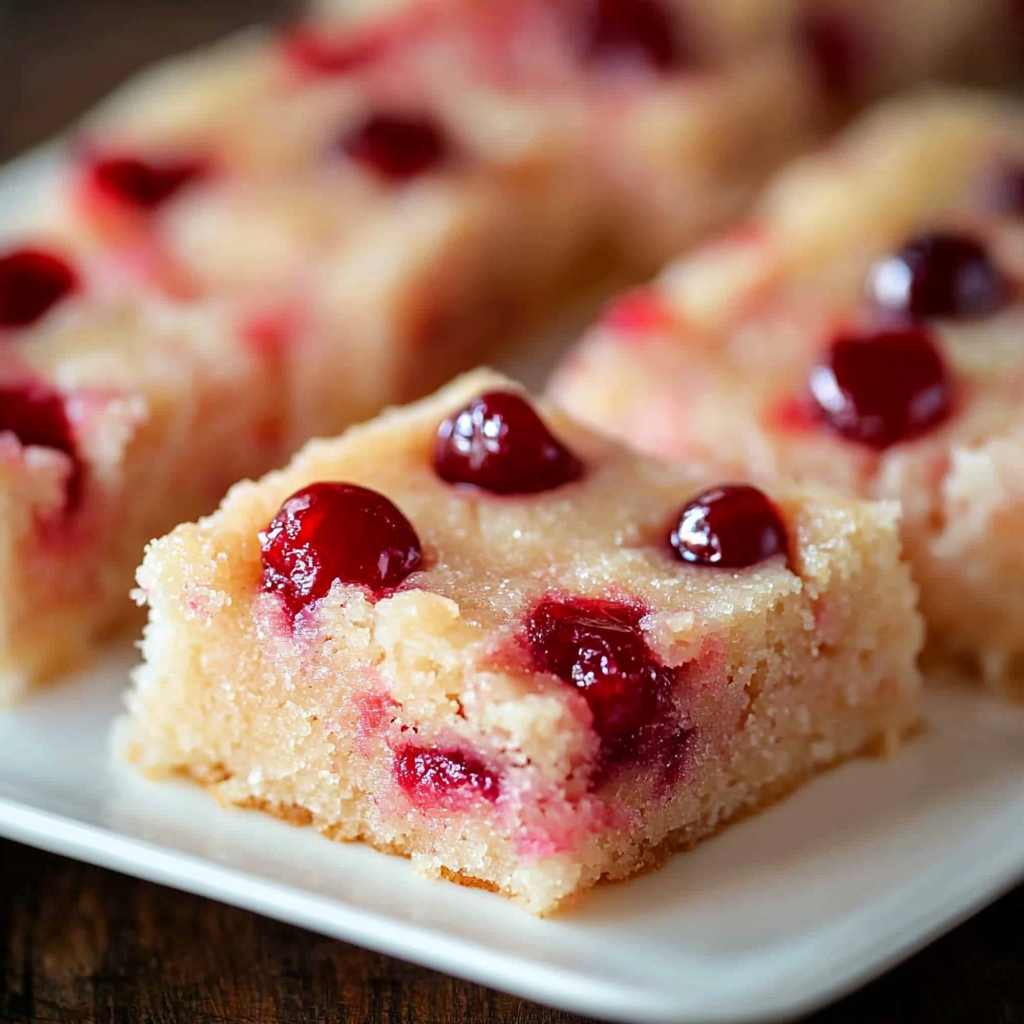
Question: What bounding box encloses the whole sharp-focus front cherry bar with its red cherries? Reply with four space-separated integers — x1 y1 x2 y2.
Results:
126 372 923 913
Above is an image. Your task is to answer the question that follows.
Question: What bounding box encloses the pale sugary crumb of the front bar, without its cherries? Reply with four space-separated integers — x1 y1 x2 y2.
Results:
128 372 921 913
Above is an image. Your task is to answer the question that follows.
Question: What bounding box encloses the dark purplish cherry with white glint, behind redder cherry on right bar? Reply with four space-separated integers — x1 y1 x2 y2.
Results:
868 233 1010 318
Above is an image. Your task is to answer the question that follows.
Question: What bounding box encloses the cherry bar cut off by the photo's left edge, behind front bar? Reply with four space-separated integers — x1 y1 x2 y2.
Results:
0 246 288 703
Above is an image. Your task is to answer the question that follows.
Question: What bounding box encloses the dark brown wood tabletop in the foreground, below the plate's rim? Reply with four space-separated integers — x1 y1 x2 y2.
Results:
0 841 1024 1024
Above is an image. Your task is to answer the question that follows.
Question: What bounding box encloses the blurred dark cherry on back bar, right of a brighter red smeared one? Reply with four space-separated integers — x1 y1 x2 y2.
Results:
341 114 451 182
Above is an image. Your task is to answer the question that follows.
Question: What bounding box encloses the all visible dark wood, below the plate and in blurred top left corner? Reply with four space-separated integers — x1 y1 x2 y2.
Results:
0 0 1024 1024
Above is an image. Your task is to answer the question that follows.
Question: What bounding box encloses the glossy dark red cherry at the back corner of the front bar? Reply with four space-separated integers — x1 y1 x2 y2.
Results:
434 391 583 495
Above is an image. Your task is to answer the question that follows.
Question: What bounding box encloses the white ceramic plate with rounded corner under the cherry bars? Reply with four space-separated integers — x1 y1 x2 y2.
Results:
0 144 1024 1022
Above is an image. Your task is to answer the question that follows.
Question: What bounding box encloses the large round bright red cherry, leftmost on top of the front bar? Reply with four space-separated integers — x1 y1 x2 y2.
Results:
262 483 423 614
